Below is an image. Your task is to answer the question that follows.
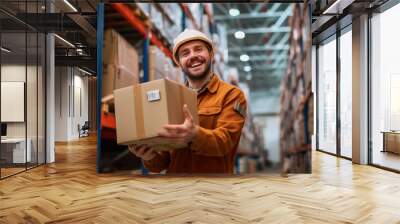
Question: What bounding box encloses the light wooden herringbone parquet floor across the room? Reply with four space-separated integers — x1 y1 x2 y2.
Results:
0 137 400 224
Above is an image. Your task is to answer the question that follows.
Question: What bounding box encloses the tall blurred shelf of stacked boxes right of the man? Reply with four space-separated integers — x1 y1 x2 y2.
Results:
280 4 313 172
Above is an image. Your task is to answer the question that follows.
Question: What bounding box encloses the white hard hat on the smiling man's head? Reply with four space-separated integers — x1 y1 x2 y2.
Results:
172 29 214 65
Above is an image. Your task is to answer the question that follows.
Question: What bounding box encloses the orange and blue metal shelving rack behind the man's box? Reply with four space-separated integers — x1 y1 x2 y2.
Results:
97 3 213 174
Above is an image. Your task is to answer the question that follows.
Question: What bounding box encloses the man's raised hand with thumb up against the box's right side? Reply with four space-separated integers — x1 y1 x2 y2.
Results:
158 104 197 143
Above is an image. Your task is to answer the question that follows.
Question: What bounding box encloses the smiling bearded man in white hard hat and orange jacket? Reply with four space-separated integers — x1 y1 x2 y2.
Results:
129 29 246 173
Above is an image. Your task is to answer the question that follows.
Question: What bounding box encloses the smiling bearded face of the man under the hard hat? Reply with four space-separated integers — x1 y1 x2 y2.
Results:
178 40 213 80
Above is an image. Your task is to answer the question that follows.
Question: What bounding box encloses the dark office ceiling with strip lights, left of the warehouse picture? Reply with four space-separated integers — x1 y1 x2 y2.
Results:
0 0 99 73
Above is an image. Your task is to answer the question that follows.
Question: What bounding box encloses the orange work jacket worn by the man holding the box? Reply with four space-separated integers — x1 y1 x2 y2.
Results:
144 74 247 174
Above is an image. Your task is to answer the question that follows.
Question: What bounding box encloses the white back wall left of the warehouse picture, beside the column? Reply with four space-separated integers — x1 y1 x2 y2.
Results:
55 67 88 141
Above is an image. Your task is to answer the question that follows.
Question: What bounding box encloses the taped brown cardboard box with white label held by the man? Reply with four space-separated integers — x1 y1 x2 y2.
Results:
114 79 198 150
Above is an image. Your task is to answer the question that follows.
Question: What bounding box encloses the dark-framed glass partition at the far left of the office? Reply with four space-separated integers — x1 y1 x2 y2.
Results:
0 1 46 178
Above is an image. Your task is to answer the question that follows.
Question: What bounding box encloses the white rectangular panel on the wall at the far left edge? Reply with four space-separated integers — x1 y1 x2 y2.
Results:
1 82 25 122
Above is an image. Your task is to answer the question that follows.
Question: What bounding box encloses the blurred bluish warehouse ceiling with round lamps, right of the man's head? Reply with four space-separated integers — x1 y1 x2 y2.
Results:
213 3 292 94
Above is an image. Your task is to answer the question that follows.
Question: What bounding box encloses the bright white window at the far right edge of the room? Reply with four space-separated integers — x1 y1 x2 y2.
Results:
370 4 400 170
